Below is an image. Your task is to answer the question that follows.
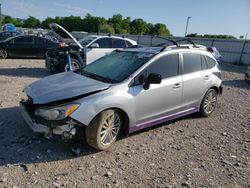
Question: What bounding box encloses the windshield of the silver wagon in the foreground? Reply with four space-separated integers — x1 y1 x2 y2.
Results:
82 50 154 83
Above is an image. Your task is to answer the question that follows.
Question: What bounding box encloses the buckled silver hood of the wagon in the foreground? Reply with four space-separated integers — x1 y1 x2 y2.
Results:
25 72 111 104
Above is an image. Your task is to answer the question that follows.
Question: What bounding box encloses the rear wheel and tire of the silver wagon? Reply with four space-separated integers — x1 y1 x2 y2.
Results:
200 89 218 117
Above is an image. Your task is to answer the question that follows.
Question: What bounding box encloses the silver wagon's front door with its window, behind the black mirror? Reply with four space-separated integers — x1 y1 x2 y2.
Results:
132 54 182 125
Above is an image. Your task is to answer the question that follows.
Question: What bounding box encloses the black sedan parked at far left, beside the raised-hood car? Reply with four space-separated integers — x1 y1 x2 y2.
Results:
0 35 59 59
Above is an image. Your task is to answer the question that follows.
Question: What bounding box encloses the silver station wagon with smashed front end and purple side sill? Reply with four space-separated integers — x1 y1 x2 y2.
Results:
20 42 222 150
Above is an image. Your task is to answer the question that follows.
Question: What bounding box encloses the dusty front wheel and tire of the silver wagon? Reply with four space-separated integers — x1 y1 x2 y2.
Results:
85 109 123 150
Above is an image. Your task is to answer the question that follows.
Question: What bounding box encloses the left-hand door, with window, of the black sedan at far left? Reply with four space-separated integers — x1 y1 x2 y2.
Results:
8 36 33 57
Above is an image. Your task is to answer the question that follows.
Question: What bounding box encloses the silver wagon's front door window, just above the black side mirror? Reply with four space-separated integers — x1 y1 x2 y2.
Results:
148 54 179 79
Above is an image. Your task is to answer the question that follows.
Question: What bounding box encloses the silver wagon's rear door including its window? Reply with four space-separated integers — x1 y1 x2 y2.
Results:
181 52 212 108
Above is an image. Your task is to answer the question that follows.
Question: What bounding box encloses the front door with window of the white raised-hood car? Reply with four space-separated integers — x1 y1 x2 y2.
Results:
86 37 114 64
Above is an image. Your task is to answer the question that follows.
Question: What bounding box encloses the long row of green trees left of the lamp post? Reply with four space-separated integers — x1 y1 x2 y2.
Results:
2 14 172 36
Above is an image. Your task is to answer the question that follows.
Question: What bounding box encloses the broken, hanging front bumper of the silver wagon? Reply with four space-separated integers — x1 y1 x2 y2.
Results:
20 102 76 139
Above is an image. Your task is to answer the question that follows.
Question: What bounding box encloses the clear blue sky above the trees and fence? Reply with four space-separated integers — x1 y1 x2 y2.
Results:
0 0 250 39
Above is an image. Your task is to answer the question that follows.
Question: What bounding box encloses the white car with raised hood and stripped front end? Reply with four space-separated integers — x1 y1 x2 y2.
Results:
45 23 137 72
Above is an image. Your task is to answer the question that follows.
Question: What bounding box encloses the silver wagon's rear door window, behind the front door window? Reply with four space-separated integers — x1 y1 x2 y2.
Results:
183 53 202 74
